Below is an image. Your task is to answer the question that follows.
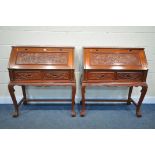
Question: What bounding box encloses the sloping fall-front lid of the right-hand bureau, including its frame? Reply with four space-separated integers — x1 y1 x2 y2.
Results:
84 47 148 70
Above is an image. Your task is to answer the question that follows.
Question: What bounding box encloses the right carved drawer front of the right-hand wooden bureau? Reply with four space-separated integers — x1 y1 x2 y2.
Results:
117 72 143 81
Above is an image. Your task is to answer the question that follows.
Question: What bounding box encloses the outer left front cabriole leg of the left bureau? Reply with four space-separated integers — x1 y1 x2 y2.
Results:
8 84 19 117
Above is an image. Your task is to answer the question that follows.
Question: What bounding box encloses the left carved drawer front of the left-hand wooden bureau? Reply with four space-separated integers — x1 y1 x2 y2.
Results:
14 71 42 81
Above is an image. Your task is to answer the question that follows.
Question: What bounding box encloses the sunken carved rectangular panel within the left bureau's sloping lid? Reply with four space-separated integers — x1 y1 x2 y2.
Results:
16 52 68 65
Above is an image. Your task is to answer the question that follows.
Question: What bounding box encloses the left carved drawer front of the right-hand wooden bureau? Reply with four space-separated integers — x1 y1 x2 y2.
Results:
87 71 115 80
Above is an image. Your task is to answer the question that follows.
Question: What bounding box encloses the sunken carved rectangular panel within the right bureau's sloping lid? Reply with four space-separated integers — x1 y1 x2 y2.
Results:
90 52 141 66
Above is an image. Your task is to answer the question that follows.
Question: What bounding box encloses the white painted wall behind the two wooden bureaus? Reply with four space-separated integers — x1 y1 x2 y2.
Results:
0 26 155 103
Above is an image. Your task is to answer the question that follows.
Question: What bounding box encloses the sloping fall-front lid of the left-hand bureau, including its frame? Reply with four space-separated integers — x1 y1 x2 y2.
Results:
8 46 74 69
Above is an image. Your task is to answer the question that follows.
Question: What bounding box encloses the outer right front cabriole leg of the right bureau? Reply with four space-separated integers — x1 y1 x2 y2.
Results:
136 86 148 117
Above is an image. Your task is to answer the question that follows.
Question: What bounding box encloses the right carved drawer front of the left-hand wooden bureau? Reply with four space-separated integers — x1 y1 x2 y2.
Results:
43 71 72 80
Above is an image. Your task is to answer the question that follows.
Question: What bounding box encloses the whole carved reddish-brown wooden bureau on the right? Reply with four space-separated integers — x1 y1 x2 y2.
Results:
80 47 148 117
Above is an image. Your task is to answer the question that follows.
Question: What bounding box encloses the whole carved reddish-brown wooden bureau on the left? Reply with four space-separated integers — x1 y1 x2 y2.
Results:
8 47 76 117
